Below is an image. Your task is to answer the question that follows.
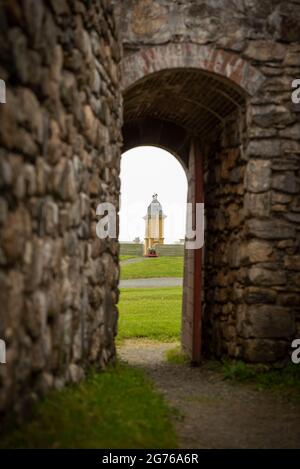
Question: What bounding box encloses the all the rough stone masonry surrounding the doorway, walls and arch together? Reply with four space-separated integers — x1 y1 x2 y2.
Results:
0 0 300 414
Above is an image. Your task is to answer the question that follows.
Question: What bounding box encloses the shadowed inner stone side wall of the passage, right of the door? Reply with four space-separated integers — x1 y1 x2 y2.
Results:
202 109 246 357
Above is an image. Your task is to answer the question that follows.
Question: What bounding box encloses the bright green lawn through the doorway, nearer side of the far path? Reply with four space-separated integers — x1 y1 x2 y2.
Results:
117 287 182 341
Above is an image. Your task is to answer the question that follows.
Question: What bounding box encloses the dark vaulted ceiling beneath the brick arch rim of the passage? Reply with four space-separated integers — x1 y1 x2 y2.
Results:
124 69 245 137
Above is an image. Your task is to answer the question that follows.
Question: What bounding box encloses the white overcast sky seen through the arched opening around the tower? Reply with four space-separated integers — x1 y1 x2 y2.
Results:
119 147 187 243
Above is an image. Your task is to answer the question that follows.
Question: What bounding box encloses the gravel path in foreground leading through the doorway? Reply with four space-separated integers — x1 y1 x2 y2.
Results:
119 340 300 448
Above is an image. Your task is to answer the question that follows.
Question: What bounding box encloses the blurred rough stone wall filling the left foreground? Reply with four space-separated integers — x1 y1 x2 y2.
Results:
0 0 121 414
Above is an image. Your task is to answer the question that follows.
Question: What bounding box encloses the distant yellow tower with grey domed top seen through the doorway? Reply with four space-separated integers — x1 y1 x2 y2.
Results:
143 194 166 255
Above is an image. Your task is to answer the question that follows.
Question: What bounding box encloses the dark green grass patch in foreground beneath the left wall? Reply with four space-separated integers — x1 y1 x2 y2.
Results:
0 364 177 448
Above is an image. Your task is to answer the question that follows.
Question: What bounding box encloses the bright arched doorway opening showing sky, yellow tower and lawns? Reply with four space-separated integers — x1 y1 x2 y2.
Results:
118 146 187 347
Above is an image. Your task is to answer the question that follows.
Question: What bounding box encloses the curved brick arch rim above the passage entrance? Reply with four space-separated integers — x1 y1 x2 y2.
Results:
122 43 265 96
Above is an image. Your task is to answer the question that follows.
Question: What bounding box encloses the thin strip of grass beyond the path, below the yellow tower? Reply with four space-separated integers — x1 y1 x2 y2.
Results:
121 257 183 280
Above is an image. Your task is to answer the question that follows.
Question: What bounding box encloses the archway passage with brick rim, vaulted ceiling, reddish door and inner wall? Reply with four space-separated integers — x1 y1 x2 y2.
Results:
123 44 263 363
